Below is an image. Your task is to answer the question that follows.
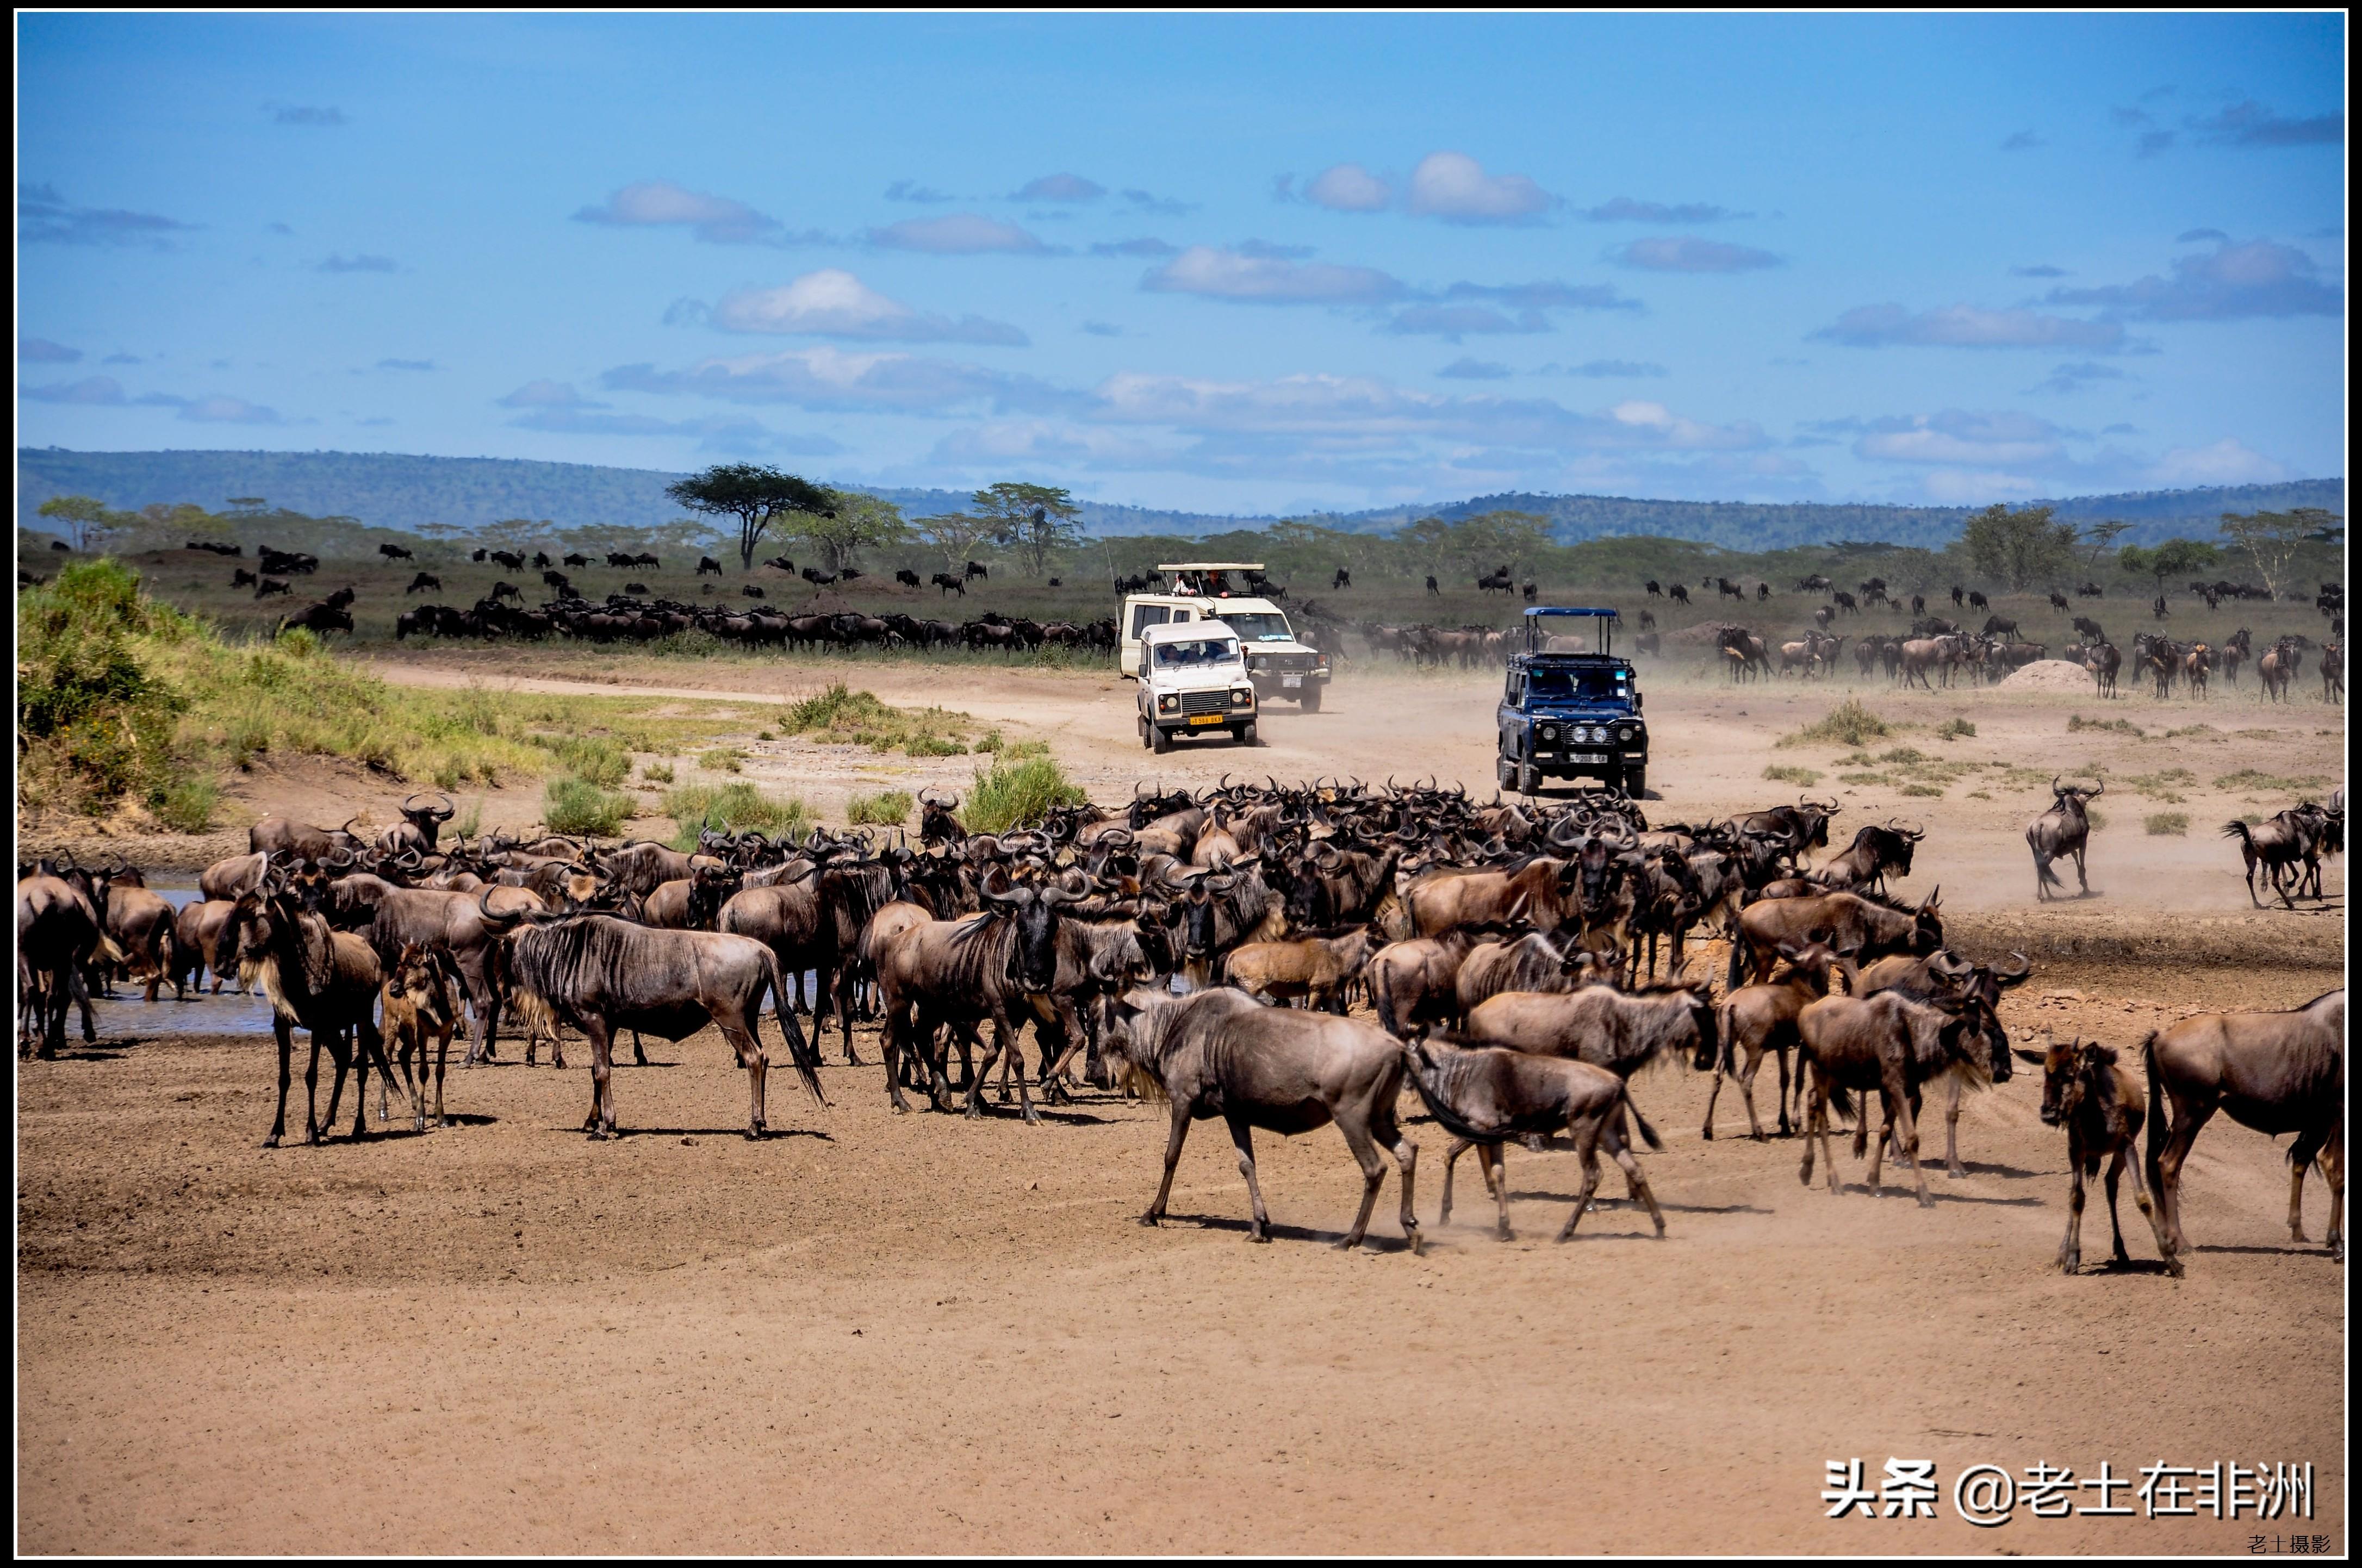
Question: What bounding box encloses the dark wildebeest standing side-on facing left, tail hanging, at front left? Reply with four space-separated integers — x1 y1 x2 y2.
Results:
482 906 829 1138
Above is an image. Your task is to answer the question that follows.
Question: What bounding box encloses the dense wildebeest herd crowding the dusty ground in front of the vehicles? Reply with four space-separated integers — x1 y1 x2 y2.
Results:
16 779 2346 1273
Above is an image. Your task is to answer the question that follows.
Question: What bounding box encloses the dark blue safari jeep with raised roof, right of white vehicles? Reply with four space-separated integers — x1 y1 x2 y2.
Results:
1495 609 1649 800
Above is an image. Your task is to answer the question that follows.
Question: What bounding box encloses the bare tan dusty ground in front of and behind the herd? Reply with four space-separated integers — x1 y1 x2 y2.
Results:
16 659 2346 1552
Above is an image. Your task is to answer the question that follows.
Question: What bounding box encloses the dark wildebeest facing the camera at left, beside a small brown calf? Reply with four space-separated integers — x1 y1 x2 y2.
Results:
225 874 392 1148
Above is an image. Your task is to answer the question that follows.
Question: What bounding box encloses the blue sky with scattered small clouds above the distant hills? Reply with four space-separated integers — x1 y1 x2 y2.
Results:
16 14 2348 513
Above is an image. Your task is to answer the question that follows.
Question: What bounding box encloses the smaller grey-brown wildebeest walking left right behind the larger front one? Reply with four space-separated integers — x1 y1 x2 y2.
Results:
1403 1037 1665 1242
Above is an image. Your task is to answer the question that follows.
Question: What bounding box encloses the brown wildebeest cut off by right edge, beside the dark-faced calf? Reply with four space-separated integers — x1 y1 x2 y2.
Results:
2140 985 2346 1259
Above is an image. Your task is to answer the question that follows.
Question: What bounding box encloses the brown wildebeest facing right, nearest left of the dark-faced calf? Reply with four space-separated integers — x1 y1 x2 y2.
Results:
1795 992 1986 1209
